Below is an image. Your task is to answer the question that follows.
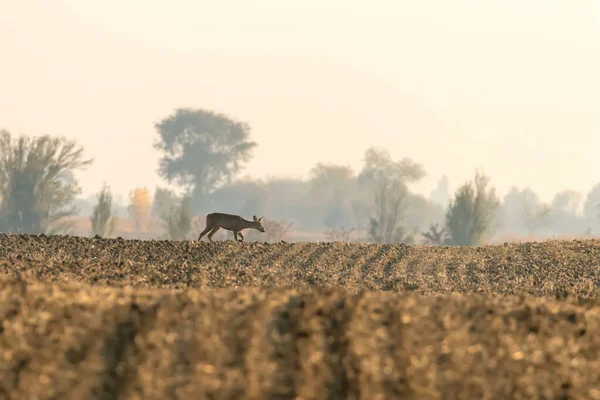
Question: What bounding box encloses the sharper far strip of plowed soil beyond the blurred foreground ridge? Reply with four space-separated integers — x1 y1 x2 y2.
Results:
0 234 600 298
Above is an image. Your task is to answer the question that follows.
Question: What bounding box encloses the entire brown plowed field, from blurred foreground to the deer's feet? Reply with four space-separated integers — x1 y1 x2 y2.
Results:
0 235 600 399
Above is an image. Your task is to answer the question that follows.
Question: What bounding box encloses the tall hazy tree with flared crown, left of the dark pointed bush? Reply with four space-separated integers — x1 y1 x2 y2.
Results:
358 148 425 243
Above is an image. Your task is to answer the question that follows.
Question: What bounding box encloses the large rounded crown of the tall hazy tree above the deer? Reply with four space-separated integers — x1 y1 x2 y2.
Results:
154 108 256 211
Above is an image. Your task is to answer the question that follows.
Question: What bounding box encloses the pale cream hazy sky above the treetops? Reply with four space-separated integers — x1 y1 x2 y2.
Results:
0 0 600 201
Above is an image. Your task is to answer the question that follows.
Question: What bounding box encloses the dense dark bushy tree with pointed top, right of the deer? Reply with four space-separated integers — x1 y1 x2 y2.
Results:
446 171 500 246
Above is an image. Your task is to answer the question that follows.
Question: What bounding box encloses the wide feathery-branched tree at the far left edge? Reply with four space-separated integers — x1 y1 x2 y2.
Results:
0 130 93 233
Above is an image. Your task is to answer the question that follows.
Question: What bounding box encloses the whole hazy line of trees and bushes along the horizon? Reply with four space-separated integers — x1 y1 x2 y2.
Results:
0 109 600 245
